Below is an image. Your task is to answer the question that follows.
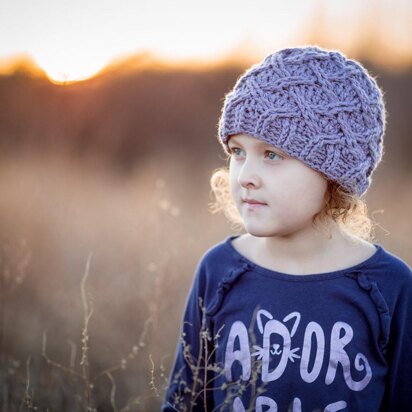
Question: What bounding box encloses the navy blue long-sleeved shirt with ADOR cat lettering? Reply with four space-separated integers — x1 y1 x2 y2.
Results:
162 236 412 412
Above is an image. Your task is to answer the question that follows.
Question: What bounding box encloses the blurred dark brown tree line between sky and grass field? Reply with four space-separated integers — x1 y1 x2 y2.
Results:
0 52 412 172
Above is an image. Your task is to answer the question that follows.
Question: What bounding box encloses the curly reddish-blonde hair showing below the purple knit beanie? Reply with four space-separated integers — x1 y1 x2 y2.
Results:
209 167 376 242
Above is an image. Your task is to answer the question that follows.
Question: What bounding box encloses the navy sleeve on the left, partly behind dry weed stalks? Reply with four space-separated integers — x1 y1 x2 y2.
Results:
162 262 213 412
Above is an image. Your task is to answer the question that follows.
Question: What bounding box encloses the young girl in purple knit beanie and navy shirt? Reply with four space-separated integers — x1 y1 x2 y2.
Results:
162 47 412 412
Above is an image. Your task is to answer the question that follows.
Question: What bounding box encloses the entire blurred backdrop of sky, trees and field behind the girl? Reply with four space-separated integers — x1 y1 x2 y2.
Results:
0 0 412 411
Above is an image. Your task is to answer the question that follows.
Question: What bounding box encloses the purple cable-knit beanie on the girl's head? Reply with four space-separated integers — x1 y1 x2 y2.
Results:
218 46 385 197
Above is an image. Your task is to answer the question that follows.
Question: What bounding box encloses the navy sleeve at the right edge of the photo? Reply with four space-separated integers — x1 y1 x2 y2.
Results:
382 269 412 412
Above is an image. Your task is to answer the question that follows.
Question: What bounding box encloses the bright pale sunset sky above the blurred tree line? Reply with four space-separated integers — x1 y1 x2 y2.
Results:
0 0 412 81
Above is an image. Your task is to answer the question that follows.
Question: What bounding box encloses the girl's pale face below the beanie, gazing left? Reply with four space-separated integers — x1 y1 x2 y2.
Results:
228 134 327 237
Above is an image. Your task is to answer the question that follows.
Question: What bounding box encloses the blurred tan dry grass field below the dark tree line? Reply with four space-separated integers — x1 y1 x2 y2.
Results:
0 153 412 412
